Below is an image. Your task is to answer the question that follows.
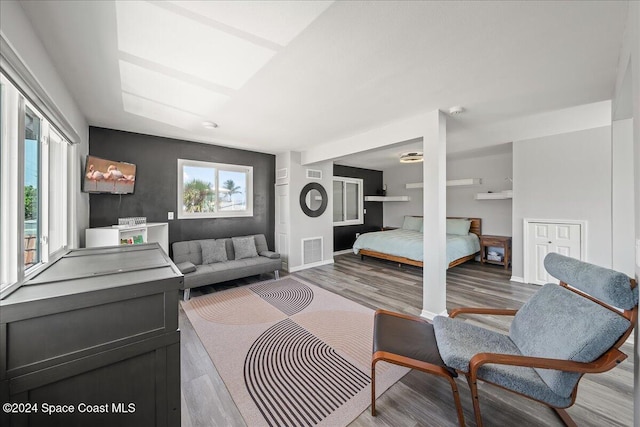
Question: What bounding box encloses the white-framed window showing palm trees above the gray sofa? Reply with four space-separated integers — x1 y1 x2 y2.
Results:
178 159 253 219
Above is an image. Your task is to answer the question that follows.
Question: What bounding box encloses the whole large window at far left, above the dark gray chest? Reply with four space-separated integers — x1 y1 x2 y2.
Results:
0 74 69 291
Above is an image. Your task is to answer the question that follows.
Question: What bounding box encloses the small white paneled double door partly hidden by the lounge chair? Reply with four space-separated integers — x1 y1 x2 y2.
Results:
525 222 582 285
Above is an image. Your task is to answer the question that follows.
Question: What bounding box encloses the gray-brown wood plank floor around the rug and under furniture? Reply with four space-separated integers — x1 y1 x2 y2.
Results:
179 254 633 427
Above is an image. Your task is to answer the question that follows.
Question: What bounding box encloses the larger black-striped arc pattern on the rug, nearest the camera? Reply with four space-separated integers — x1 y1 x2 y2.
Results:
244 319 371 426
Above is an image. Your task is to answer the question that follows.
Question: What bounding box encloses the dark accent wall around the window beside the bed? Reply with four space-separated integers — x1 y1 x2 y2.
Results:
333 165 383 251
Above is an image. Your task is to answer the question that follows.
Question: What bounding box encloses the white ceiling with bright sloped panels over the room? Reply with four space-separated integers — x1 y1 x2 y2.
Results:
21 0 628 169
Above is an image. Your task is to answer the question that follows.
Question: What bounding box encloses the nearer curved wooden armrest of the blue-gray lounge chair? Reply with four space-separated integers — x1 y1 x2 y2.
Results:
469 348 627 381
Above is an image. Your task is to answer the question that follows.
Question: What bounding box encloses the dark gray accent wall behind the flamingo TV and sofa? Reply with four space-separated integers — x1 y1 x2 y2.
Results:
89 127 276 249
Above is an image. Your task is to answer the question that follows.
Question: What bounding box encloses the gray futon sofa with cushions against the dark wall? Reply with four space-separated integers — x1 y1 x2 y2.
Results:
172 234 282 301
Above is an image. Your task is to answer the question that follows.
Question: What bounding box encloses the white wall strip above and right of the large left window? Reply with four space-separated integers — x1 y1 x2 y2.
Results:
0 0 89 247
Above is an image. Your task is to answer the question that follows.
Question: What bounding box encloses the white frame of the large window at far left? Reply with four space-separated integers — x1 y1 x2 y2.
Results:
0 70 72 298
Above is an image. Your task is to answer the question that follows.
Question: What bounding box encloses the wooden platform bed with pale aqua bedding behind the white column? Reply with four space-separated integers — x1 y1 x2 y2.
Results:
353 216 482 268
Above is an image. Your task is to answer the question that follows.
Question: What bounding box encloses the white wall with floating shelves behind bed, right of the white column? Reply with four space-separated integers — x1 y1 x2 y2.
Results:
447 149 513 236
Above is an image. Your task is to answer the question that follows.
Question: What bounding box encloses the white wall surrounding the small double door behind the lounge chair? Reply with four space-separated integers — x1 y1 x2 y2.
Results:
512 126 611 278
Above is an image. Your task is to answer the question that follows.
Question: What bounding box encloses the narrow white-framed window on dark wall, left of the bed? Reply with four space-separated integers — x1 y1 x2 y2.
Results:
333 177 364 226
